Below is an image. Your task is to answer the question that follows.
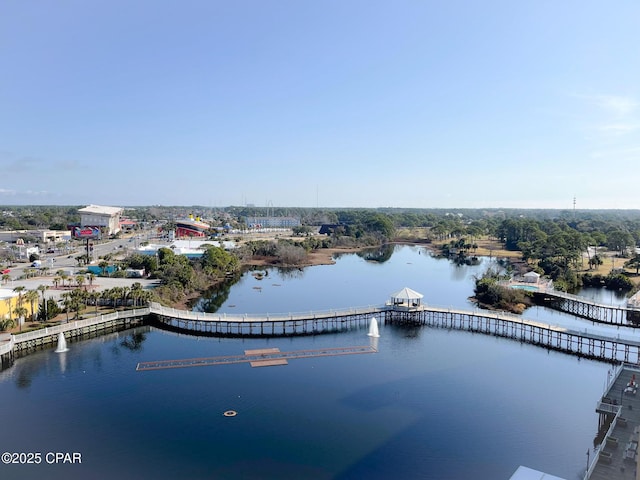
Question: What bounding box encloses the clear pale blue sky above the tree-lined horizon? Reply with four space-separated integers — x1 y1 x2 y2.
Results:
0 0 640 209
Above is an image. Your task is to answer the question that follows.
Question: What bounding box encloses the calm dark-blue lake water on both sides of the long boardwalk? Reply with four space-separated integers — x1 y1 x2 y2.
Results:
0 247 610 480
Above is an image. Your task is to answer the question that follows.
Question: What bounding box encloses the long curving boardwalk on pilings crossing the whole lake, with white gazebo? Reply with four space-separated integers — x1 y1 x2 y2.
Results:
0 296 640 367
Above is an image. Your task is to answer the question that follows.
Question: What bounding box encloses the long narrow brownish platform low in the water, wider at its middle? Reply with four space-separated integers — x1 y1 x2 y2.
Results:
136 345 377 372
